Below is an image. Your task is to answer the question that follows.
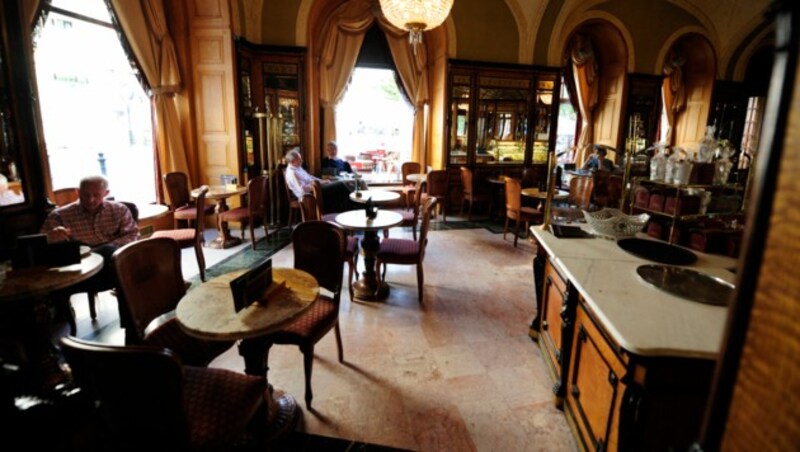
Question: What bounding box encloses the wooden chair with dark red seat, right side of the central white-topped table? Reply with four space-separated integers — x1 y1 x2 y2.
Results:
375 197 437 303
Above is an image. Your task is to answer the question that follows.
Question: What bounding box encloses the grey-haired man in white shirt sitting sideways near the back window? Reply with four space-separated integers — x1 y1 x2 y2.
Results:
285 148 354 213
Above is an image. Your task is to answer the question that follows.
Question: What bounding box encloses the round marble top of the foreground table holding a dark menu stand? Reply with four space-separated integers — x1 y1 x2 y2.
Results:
175 268 320 340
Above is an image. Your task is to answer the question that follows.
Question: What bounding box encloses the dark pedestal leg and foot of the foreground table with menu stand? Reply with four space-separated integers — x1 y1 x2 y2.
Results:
239 338 301 441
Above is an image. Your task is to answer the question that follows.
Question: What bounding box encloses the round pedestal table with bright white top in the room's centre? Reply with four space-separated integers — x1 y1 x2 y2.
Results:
336 210 403 301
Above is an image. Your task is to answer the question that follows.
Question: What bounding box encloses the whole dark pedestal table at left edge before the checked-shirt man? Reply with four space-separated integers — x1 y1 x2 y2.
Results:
0 253 103 394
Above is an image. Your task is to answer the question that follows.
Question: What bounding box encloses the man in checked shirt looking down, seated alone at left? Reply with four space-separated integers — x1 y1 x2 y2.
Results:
41 176 139 287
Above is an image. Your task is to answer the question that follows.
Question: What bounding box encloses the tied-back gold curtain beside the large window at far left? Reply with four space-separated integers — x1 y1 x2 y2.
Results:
111 0 192 184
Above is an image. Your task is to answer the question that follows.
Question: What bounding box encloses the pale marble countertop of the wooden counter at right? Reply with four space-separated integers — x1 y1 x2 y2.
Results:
530 226 736 358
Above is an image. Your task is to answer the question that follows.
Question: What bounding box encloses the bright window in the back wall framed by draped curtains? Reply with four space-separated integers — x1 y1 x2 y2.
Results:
336 67 414 182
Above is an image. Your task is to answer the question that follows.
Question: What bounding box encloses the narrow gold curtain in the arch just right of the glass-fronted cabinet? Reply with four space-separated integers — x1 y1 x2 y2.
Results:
570 33 599 164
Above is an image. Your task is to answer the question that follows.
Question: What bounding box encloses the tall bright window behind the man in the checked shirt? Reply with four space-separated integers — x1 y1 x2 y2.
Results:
34 0 156 203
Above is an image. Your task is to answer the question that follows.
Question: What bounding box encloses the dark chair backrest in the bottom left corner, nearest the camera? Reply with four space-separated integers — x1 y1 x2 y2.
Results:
61 337 190 450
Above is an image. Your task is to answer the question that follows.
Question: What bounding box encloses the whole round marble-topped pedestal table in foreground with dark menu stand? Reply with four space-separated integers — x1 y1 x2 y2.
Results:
175 268 319 439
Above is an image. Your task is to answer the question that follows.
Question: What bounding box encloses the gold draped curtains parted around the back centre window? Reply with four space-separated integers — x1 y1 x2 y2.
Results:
319 1 428 161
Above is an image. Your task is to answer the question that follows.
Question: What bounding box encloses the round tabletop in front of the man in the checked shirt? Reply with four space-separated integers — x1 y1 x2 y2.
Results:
0 253 103 303
